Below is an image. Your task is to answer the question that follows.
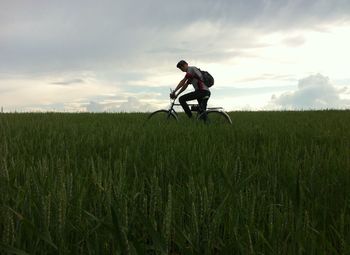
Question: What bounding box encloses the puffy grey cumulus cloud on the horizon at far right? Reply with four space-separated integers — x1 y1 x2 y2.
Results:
266 74 350 110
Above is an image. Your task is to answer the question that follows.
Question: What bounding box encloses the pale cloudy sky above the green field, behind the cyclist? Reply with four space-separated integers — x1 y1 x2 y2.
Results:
0 0 350 112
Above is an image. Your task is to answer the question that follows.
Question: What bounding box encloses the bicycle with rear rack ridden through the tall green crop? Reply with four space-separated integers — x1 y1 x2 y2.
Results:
147 89 232 124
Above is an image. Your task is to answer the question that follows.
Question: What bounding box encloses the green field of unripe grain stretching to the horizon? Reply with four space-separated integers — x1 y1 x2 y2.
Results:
0 111 350 254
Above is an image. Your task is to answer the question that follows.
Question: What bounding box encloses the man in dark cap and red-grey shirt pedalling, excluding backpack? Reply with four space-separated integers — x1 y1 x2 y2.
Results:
170 60 210 120
